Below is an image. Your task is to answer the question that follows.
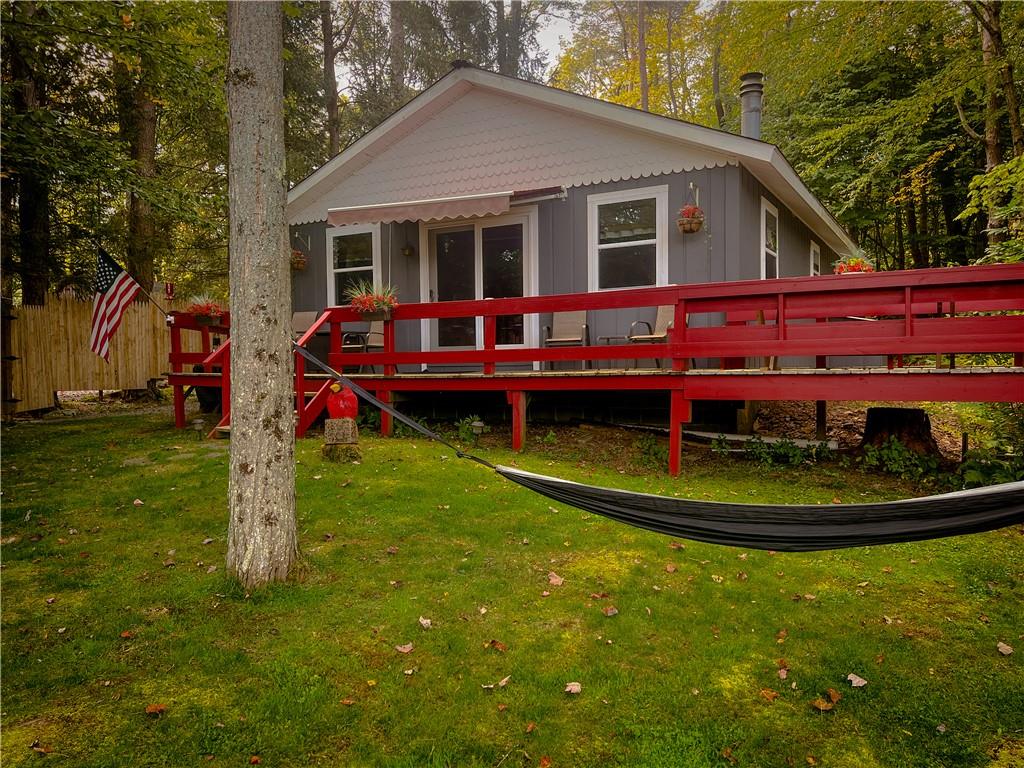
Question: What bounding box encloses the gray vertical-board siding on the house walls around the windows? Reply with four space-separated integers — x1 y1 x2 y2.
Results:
292 166 836 366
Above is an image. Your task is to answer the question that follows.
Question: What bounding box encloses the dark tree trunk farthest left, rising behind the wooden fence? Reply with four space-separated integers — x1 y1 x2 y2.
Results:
7 2 56 304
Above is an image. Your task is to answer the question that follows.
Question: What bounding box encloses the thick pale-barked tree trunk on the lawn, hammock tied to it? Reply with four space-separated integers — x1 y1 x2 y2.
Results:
227 1 298 589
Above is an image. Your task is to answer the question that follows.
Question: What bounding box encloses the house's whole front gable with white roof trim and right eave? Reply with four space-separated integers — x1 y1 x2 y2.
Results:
288 66 854 254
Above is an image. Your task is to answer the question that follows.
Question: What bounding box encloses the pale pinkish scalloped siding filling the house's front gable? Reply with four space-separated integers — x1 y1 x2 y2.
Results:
291 88 735 224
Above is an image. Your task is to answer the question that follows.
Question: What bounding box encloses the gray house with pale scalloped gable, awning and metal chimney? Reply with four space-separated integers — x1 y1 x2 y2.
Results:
288 62 854 366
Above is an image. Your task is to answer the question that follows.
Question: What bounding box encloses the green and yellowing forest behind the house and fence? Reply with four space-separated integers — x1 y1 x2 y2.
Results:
0 0 1024 303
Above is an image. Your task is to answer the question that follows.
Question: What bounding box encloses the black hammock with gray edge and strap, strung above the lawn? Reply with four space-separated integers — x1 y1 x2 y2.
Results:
296 345 1024 552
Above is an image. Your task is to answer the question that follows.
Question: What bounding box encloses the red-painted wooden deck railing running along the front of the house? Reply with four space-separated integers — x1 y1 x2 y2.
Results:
170 264 1024 468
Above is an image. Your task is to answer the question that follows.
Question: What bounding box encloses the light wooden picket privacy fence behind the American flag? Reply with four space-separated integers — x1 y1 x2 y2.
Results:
3 296 201 414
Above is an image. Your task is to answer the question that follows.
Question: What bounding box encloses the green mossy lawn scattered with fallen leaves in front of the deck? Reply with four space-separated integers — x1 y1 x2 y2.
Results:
0 414 1024 768
